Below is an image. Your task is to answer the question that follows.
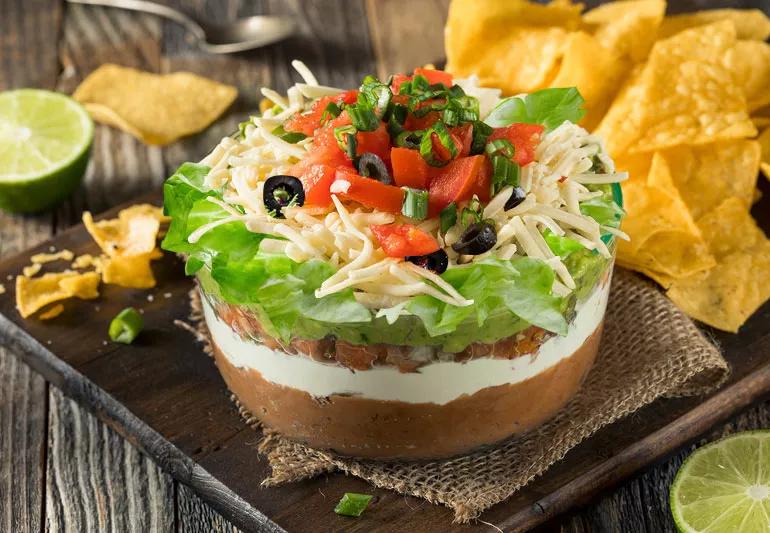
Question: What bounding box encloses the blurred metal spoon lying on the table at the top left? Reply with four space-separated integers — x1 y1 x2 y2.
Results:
68 0 296 54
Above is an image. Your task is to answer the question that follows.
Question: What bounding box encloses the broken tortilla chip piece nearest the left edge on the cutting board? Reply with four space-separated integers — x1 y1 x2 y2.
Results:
16 272 99 318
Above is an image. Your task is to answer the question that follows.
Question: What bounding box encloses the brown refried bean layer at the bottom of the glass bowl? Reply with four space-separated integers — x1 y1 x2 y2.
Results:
214 323 603 459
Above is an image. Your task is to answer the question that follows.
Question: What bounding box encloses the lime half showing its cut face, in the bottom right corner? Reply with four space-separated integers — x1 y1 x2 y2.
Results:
670 430 770 533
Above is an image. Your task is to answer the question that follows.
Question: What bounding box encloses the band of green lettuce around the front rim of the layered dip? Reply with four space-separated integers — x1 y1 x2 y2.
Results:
162 163 607 352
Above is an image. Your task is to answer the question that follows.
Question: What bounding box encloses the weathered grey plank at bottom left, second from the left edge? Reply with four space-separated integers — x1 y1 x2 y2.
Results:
45 388 174 531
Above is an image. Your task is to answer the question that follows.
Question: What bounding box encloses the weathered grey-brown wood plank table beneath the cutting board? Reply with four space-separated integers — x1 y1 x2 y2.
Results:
0 0 770 532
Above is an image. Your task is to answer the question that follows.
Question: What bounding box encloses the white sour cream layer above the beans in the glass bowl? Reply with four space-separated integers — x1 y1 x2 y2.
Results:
201 282 610 405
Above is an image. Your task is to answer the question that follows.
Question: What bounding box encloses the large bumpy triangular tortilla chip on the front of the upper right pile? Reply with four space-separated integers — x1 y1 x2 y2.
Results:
598 21 756 154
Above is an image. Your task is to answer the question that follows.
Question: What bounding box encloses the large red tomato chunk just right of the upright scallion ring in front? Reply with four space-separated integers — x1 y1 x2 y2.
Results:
428 155 489 216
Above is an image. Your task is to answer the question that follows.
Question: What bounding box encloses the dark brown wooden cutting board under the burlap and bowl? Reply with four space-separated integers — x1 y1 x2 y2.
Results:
0 180 770 532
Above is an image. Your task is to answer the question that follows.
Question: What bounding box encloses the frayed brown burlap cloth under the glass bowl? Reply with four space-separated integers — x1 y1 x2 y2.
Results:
182 268 729 523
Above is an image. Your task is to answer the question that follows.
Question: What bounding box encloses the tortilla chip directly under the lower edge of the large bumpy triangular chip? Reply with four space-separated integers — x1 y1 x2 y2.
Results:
661 139 760 220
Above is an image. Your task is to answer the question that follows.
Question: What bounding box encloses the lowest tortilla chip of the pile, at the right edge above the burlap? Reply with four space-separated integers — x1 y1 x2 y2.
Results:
667 198 770 332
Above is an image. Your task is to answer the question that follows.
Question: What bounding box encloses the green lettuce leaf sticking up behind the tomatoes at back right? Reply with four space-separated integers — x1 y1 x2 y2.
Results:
484 87 586 130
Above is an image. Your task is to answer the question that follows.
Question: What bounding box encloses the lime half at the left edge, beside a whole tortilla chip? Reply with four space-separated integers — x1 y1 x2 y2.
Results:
0 89 94 212
